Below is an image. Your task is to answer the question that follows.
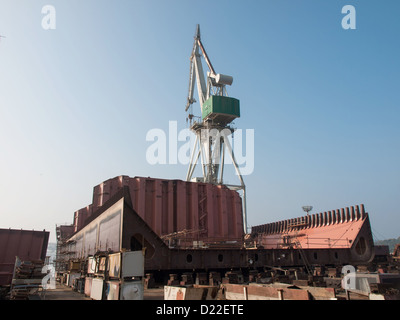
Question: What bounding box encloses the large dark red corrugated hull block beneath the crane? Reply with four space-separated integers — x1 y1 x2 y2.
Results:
74 176 244 241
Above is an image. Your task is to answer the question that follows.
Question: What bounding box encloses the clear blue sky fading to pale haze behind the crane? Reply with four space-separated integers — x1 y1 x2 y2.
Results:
0 0 400 241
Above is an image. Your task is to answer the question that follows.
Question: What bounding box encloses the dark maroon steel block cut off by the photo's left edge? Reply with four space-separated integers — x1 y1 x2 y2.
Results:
0 229 50 285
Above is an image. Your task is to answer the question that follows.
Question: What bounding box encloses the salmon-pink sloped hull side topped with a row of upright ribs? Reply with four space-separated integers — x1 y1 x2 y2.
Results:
252 205 373 262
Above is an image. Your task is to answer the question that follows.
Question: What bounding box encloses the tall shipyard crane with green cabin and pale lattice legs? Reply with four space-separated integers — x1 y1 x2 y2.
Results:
185 25 247 233
